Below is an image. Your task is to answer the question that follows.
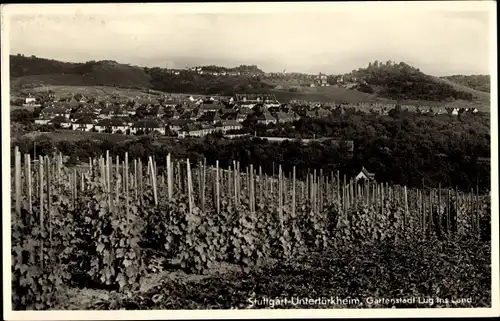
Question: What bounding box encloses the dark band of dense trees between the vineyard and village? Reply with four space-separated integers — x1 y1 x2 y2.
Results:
12 107 491 191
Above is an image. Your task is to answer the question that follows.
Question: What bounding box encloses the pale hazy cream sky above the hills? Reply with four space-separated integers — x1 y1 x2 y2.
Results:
5 4 494 76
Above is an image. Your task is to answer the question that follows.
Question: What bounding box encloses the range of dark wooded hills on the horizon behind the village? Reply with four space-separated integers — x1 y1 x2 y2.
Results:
10 55 490 111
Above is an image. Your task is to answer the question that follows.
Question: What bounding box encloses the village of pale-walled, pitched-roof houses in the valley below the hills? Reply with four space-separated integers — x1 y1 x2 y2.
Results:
23 89 478 137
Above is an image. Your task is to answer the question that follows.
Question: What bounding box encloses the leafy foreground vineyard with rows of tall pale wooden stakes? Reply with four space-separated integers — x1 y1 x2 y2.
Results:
11 148 491 310
